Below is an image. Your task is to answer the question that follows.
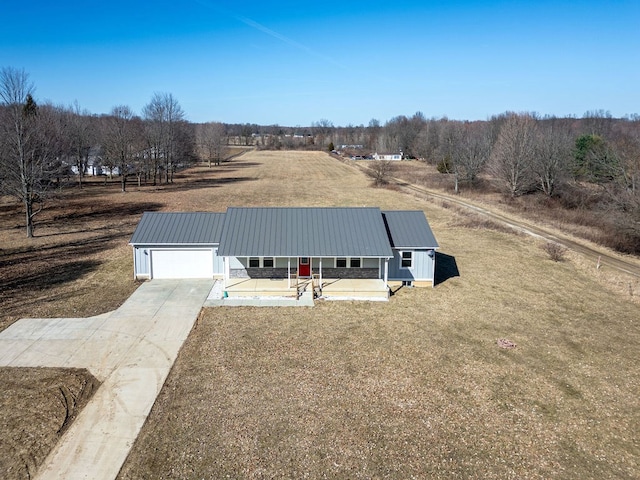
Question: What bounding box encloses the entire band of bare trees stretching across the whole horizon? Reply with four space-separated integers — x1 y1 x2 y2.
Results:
0 67 640 251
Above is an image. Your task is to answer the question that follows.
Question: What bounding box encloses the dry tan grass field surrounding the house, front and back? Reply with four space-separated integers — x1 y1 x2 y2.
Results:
0 152 640 479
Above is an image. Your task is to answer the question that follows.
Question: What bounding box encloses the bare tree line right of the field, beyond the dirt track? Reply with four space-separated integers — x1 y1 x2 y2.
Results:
246 110 640 254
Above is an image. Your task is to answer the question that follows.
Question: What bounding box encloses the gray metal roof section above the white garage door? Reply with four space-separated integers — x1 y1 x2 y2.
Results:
129 212 225 245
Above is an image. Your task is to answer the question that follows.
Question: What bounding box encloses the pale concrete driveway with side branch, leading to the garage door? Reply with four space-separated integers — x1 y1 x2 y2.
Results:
0 280 213 479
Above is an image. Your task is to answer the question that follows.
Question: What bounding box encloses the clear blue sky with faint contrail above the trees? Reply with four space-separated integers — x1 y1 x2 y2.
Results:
0 0 640 126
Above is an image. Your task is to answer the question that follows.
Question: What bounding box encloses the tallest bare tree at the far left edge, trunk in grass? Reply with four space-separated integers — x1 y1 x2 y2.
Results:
0 67 60 238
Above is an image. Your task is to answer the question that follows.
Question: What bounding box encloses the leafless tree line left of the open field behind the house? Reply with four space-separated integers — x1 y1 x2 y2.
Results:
0 67 226 237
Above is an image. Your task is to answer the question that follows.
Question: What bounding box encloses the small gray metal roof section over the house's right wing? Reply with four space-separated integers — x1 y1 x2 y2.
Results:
382 210 439 248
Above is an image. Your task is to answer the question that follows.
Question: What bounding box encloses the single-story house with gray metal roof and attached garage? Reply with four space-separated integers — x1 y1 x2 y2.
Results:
130 207 439 291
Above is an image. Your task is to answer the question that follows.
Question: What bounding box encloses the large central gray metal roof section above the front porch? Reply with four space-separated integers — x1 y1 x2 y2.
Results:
218 207 393 257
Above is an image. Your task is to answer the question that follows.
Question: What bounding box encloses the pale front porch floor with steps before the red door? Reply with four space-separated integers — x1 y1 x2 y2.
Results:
224 276 389 301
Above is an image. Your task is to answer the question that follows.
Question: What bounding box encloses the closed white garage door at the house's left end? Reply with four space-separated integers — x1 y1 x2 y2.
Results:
151 250 213 278
